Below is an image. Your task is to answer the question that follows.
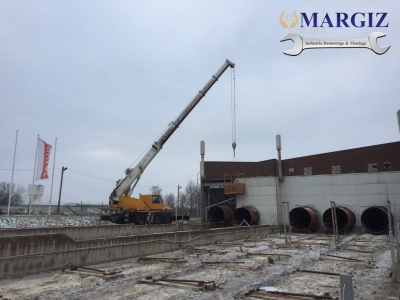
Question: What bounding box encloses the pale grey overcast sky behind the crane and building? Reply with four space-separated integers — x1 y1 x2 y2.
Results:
0 0 400 204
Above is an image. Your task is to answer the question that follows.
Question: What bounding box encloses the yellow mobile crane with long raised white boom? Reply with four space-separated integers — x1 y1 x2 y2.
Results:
100 60 235 225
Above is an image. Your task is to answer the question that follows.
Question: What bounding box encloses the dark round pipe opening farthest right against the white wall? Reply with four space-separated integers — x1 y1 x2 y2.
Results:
361 206 393 234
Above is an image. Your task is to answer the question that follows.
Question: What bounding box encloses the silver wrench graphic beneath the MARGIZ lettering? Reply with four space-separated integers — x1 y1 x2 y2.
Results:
281 32 390 56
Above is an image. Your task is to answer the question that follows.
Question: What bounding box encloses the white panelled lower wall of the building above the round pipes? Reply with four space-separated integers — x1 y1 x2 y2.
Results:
236 171 400 228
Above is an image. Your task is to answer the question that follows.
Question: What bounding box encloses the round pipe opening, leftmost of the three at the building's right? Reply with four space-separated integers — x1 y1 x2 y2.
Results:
289 206 320 233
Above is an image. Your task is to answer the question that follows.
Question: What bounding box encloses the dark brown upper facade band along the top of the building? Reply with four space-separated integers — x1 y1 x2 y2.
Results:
204 142 400 181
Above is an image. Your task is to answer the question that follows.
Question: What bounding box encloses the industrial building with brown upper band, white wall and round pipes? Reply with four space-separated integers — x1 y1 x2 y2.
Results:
201 142 400 233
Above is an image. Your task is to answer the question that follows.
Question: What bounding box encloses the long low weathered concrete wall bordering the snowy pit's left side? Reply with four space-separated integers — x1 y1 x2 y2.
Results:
0 225 280 278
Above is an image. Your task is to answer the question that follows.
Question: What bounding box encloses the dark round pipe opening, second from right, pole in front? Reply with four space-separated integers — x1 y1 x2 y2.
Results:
322 206 356 234
